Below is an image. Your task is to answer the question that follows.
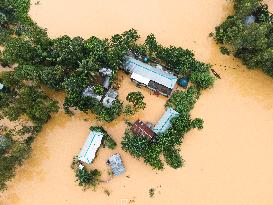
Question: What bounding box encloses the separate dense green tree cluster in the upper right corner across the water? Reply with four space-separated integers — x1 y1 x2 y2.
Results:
215 0 273 77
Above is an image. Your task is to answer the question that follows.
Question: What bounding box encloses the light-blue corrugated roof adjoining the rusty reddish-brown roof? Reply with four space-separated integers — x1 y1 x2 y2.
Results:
153 107 179 134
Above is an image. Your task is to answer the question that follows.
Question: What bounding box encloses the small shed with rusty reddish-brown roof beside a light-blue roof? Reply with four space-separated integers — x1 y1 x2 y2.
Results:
131 120 156 140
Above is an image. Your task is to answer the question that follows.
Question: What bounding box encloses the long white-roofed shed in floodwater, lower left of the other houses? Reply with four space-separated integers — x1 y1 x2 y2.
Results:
78 131 103 164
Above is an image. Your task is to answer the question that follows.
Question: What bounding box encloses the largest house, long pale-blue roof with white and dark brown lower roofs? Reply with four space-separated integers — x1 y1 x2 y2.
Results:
123 56 177 96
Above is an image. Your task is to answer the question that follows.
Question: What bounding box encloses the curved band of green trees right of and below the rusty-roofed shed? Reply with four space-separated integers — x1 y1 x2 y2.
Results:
121 87 203 169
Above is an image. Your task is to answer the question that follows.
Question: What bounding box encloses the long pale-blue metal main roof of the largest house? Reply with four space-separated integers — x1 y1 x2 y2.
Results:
125 57 177 89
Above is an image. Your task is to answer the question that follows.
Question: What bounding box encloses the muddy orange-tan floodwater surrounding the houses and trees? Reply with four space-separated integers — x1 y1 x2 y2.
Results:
0 0 273 205
